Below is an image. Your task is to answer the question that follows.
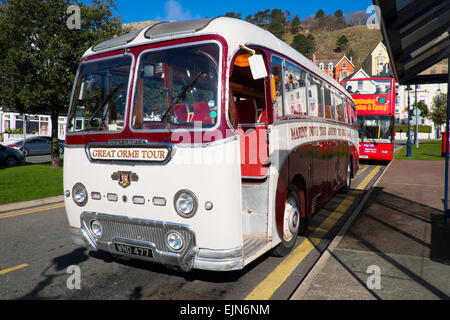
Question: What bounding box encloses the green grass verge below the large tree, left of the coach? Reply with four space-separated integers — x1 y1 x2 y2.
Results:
0 163 63 204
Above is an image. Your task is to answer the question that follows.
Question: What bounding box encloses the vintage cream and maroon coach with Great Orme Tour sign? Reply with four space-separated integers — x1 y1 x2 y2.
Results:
64 17 359 271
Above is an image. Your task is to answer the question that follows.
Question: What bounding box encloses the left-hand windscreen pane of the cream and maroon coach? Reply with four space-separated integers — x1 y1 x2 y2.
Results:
68 55 132 132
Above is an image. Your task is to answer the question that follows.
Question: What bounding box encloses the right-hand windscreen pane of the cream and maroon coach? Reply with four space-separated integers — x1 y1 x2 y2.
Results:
131 43 220 130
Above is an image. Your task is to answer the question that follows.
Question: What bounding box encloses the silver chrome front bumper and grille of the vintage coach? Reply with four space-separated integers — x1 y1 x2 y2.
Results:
71 212 244 272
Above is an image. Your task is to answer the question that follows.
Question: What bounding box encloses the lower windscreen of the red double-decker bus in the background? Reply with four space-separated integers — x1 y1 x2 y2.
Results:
358 116 394 143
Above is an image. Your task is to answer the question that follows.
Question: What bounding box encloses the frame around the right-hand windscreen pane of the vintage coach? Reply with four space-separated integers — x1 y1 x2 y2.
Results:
128 40 224 133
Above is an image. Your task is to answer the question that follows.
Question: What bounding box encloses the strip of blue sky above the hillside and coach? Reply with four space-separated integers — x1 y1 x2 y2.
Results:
116 0 373 23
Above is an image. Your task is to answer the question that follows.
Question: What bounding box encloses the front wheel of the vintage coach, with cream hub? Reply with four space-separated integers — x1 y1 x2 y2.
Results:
273 186 307 257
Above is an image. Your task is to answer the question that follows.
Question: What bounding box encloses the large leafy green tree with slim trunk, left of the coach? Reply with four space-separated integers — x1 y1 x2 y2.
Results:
0 0 124 167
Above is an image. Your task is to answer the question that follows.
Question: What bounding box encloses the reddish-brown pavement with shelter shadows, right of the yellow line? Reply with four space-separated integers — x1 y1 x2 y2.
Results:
291 160 450 300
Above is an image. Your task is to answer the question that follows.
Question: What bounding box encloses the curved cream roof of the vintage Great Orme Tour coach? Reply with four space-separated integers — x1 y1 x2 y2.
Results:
83 17 351 99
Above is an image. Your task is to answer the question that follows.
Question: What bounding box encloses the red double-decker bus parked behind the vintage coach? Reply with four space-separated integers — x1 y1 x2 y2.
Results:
341 77 395 161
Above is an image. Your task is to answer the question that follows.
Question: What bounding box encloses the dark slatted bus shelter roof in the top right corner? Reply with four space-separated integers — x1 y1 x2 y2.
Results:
373 0 450 85
